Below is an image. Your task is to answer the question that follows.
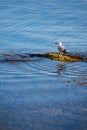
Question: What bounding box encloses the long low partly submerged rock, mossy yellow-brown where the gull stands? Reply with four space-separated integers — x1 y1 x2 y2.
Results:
0 52 87 62
